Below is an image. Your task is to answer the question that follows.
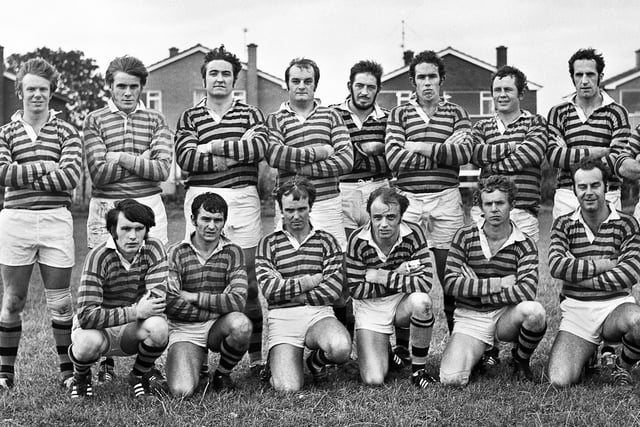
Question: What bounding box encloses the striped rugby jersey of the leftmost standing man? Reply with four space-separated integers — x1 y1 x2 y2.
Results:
0 110 82 210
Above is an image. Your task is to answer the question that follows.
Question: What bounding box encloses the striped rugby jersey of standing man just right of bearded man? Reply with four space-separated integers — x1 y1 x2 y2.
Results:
385 93 473 193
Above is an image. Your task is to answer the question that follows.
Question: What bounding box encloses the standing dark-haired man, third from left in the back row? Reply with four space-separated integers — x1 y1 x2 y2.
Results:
175 45 267 375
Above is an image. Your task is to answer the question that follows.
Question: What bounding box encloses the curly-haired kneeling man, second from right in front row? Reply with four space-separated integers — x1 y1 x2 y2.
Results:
440 175 547 386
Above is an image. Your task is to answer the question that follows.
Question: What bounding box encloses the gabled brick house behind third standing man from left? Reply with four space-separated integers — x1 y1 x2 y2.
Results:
143 43 287 130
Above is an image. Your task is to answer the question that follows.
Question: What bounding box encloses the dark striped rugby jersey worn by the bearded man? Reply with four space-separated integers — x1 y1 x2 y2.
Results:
330 98 391 182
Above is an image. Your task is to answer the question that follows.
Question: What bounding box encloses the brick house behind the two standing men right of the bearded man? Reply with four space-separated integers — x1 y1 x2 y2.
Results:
378 46 542 122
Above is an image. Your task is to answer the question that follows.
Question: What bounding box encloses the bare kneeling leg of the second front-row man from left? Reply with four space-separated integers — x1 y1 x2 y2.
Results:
166 341 206 398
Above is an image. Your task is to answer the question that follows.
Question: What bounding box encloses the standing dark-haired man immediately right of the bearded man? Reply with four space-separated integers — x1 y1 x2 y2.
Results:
385 50 473 332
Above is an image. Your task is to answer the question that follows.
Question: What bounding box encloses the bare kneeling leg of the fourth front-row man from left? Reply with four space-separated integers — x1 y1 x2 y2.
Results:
356 329 389 385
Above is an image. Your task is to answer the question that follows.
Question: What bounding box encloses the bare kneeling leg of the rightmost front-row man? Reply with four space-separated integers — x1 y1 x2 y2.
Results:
549 331 598 387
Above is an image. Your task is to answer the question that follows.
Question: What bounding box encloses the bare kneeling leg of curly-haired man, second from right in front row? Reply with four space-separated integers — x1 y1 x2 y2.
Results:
440 333 487 387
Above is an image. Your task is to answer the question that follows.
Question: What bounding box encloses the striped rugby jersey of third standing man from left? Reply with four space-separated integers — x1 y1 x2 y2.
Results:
175 98 268 188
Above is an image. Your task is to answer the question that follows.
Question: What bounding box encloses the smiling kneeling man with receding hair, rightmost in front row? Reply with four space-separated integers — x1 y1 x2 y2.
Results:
549 157 640 386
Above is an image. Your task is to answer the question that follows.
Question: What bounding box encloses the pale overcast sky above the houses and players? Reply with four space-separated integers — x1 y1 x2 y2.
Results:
0 0 640 115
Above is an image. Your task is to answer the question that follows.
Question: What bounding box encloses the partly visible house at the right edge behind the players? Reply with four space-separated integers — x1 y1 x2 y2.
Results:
600 49 640 127
